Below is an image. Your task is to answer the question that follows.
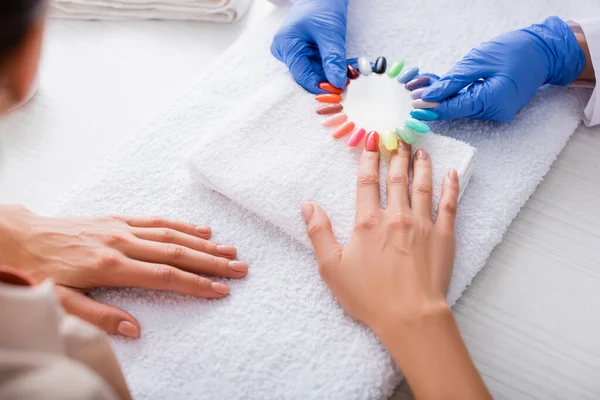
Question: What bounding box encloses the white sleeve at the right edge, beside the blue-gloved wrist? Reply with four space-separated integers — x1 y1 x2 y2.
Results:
573 18 600 126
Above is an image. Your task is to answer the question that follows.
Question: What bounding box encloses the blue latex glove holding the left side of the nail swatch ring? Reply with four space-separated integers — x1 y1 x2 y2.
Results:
271 0 348 93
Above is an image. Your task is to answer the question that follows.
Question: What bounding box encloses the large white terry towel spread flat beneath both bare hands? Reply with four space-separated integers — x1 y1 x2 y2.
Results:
52 0 600 399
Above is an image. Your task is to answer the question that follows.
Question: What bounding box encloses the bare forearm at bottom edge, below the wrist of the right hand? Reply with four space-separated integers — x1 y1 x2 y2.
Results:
379 306 491 400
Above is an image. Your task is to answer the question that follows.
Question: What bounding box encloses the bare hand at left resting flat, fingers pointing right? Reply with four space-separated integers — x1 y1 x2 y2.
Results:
0 206 248 337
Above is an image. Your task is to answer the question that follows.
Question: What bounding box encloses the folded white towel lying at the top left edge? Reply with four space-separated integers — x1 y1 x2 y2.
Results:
50 0 252 22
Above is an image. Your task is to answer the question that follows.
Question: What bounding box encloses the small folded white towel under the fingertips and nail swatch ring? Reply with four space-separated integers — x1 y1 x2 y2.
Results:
187 70 475 246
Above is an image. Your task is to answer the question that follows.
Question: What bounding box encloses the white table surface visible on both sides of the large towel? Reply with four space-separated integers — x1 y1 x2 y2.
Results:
0 1 600 400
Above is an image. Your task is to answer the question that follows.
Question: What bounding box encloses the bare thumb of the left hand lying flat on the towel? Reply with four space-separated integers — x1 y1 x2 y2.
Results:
56 286 140 338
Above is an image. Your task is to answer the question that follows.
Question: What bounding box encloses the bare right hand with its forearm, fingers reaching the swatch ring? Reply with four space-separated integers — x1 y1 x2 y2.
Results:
302 142 490 399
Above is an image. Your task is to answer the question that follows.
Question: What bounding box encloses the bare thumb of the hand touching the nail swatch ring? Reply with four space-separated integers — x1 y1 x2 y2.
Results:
302 203 342 279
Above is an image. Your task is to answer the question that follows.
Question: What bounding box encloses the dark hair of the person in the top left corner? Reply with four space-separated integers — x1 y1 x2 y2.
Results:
0 0 46 67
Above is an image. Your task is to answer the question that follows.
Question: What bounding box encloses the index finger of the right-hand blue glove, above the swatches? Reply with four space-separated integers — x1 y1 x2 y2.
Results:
421 54 487 102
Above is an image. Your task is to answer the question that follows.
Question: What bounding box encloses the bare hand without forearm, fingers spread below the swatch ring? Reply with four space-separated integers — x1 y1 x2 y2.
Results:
302 142 458 330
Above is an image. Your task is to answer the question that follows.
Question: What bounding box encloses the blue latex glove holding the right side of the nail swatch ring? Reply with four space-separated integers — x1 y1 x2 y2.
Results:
421 17 585 122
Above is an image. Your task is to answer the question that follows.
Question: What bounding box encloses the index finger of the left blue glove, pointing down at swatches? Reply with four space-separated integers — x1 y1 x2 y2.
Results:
315 29 347 88
